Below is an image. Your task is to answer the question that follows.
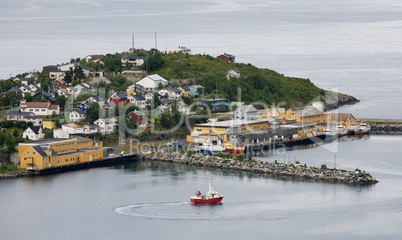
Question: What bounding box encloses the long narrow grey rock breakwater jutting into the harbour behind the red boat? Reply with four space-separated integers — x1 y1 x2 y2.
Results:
140 152 378 184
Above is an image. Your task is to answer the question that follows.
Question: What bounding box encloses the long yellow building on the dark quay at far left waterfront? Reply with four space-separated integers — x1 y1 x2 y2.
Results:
18 138 103 169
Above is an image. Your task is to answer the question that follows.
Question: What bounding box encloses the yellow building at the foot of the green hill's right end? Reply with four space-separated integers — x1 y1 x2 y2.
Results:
278 106 329 123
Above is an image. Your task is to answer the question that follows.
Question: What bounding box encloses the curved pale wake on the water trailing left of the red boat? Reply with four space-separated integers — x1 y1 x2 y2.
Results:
115 202 225 220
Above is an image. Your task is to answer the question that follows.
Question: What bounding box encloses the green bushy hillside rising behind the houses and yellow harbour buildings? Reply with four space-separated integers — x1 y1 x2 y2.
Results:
149 54 325 107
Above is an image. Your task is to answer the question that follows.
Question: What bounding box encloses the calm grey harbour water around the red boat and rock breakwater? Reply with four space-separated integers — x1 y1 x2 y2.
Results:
0 136 402 239
